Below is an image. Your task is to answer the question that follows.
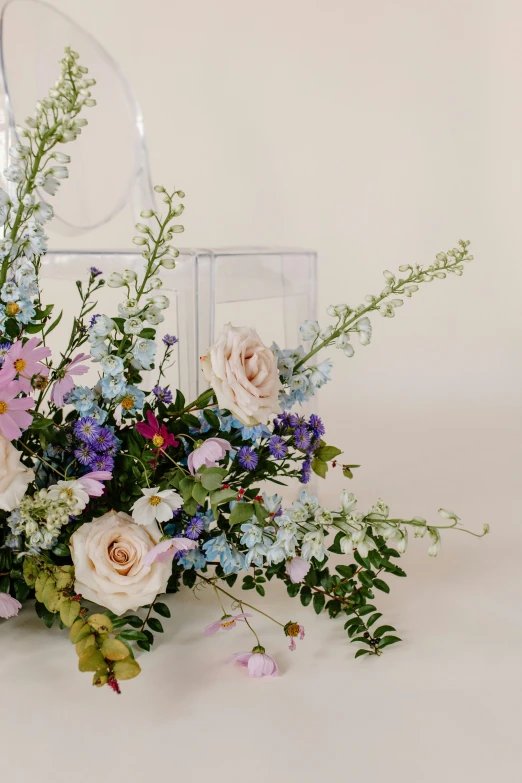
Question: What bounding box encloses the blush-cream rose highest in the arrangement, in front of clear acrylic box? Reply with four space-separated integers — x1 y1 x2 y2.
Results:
201 324 281 427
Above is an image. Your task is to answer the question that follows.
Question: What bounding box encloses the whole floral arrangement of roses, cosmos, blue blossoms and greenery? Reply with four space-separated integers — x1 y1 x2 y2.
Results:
0 49 488 693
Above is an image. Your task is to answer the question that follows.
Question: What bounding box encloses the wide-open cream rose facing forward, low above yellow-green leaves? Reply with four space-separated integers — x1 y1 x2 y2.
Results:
70 511 172 615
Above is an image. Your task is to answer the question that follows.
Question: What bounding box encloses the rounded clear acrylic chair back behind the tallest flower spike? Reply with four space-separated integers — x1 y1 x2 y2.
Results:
0 0 154 235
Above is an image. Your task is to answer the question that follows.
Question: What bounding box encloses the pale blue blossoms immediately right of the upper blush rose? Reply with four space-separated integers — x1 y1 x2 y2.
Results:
272 343 333 410
